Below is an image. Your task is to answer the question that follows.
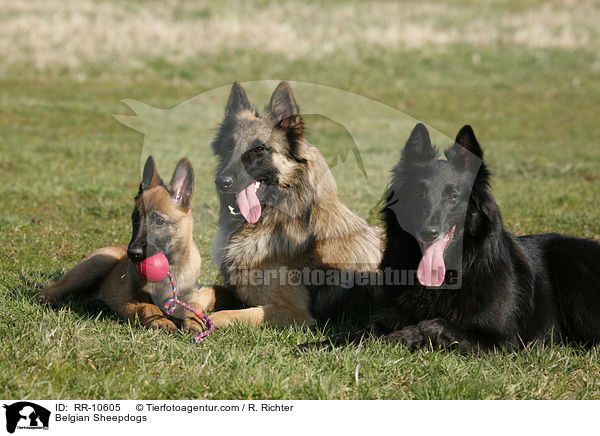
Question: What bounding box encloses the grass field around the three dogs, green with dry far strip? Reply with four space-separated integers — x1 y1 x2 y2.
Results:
0 0 600 399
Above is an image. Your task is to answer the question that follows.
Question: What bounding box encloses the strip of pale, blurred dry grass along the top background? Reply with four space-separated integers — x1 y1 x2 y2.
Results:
0 0 600 78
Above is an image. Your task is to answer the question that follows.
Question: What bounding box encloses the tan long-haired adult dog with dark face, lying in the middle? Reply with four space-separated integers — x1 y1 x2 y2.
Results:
197 82 382 327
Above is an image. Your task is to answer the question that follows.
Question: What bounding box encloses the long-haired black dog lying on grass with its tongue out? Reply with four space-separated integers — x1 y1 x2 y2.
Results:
310 124 600 351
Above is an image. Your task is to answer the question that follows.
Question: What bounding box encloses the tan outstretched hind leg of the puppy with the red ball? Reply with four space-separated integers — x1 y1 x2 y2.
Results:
38 245 127 306
